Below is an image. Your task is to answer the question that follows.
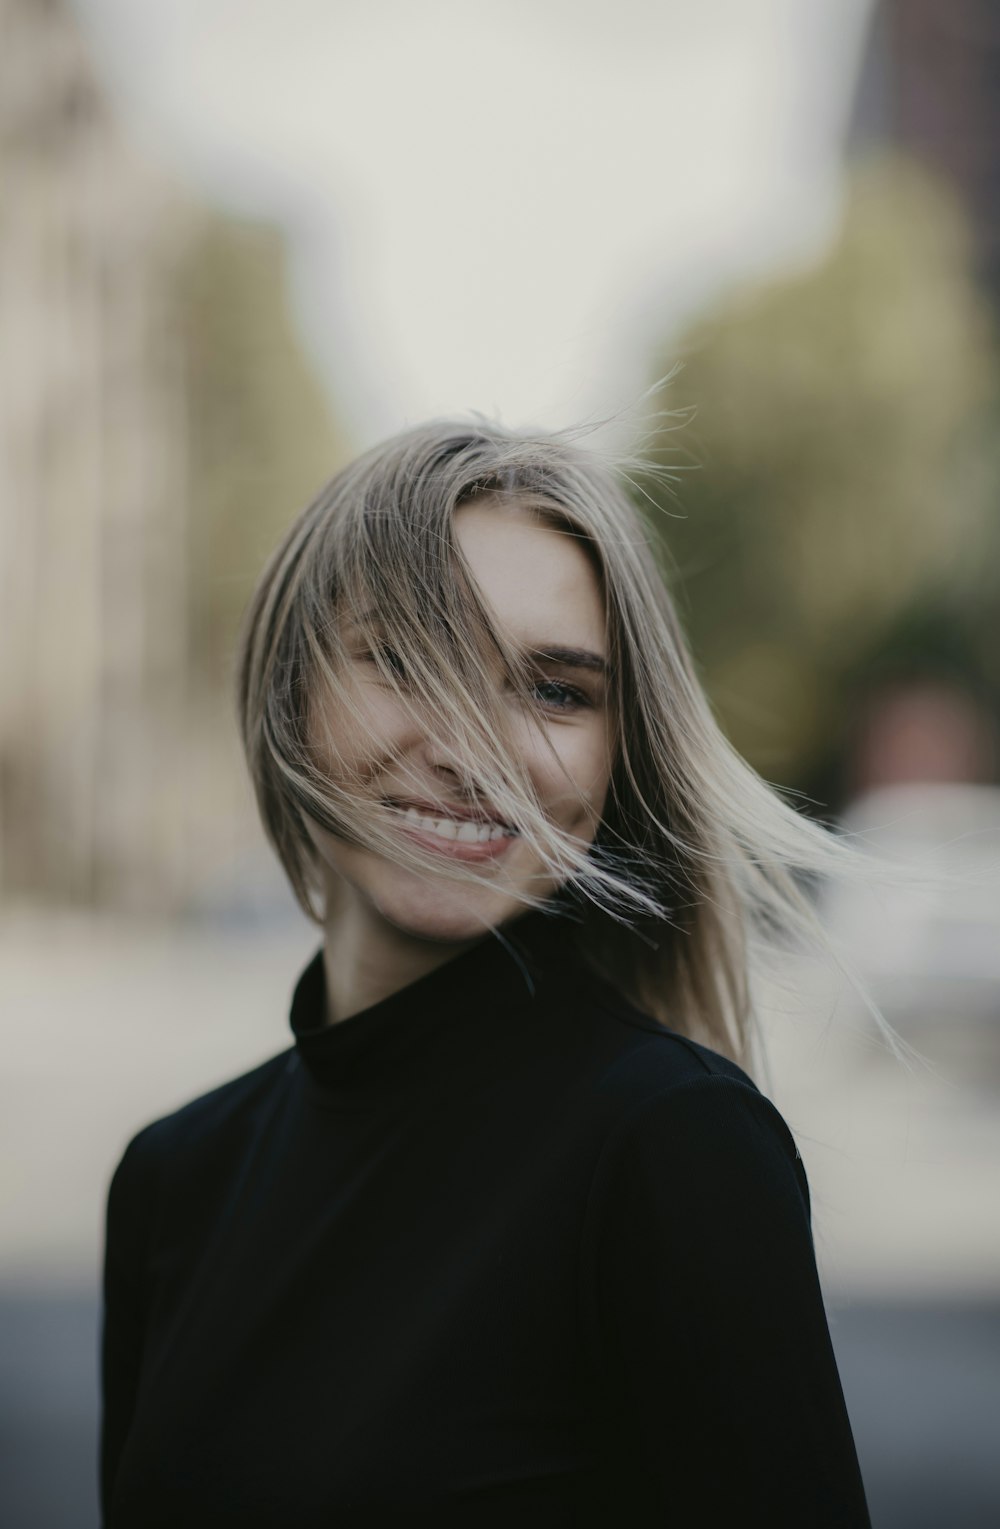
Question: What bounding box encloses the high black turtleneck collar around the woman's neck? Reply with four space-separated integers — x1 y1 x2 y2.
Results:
291 911 581 1109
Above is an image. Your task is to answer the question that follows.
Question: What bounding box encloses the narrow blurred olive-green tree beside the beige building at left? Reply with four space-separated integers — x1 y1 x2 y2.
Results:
174 216 346 690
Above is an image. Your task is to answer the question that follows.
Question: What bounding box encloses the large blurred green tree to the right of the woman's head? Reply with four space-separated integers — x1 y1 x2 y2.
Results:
641 159 998 813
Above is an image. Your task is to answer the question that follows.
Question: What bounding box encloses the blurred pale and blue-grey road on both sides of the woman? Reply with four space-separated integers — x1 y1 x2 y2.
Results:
0 913 1000 1529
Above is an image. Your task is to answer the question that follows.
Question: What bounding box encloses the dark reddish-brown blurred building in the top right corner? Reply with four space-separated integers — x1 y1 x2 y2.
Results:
850 0 1000 301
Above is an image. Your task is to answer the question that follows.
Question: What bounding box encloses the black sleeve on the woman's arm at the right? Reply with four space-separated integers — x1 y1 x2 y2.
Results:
593 1073 870 1529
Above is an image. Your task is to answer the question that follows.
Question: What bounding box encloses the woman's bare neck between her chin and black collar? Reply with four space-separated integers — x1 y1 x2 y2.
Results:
323 901 479 1024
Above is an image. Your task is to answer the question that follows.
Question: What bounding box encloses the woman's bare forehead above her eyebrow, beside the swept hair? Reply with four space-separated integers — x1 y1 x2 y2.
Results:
454 497 606 653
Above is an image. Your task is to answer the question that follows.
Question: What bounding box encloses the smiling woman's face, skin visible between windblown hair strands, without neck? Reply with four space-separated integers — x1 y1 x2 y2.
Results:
301 498 612 945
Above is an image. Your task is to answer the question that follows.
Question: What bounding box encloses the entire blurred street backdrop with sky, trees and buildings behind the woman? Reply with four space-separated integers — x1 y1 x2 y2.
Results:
0 0 1000 1529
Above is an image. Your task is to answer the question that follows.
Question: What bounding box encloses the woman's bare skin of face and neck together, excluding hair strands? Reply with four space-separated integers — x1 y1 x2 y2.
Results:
306 492 612 1018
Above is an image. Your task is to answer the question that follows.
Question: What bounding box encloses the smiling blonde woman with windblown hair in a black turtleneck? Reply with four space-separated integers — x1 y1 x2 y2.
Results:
102 424 869 1529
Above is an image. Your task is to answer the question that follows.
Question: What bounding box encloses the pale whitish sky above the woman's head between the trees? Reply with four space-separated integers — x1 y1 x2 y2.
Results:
75 0 870 445
